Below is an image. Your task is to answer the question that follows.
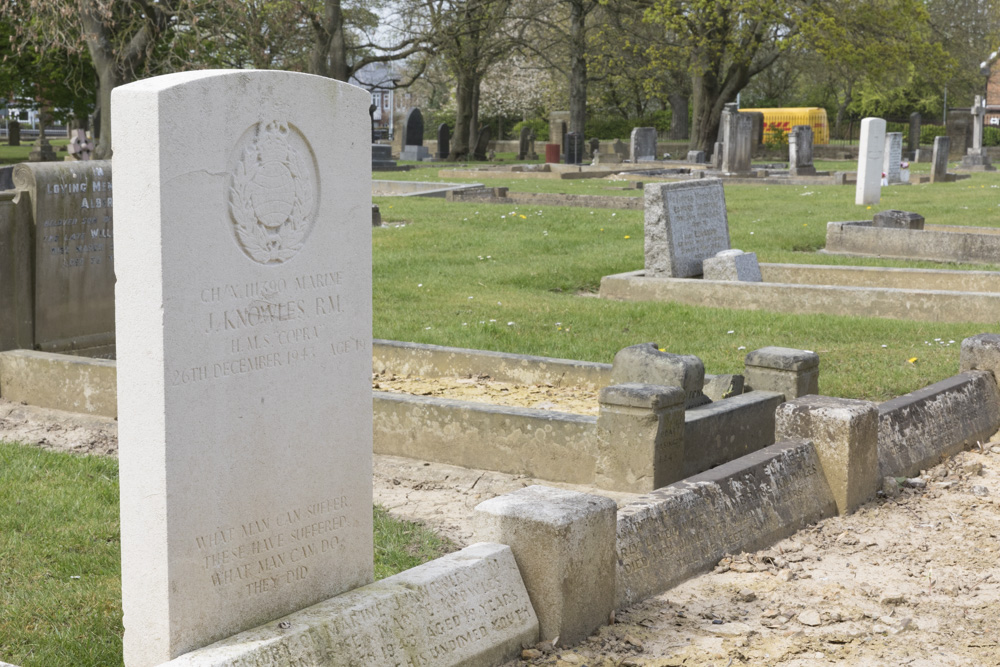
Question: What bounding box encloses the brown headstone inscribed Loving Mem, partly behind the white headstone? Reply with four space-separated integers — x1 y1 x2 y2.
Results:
13 160 115 356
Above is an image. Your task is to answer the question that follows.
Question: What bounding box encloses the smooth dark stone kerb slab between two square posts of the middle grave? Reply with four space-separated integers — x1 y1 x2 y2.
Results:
682 391 785 478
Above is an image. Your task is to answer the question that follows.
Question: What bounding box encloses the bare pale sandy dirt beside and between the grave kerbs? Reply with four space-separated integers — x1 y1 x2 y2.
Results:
0 378 1000 667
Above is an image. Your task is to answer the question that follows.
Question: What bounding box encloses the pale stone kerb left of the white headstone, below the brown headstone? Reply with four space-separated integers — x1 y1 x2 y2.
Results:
0 350 118 418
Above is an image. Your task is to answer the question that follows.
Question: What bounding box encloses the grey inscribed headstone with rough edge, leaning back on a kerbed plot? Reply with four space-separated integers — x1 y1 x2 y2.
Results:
644 178 729 278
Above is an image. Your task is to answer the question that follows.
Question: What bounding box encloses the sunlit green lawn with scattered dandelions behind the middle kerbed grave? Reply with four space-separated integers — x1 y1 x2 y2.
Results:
373 167 1000 401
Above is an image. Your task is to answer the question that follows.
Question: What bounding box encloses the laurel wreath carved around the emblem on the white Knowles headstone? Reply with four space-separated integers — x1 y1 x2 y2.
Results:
229 125 315 264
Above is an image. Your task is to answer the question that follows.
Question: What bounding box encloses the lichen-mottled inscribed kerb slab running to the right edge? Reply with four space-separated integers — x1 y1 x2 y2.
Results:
878 370 1000 477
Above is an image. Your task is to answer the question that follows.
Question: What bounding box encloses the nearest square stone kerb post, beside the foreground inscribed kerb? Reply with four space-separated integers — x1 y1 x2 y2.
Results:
475 486 617 645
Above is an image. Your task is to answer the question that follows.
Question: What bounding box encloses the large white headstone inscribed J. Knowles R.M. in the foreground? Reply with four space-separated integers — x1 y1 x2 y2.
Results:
111 70 373 667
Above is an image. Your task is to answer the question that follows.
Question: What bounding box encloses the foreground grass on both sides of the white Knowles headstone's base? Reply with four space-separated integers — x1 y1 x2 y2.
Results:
0 441 455 667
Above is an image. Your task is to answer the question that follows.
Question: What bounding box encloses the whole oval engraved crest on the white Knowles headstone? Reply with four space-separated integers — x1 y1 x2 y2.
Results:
229 120 319 264
